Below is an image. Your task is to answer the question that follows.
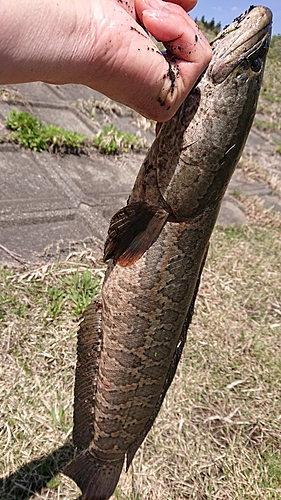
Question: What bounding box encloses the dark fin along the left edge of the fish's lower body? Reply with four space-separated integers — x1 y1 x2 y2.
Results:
73 300 101 447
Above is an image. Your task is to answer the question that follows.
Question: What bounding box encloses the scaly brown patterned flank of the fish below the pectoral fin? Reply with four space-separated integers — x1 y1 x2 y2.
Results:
90 220 208 457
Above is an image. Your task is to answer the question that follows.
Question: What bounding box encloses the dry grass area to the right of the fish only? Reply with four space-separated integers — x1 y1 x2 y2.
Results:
115 220 281 500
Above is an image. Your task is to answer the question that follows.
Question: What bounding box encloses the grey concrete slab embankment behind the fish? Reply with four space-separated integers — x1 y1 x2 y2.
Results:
0 82 281 263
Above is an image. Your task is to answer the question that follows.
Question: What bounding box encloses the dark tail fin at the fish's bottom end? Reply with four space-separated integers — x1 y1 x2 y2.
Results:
63 450 124 500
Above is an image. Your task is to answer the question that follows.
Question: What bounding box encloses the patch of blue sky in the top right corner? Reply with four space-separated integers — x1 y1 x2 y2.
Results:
190 0 281 35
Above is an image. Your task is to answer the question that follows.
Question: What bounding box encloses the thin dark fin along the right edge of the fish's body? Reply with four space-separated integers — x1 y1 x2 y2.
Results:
126 244 209 471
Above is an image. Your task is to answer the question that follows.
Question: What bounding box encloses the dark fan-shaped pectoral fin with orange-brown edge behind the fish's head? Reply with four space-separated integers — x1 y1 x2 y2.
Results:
104 201 169 267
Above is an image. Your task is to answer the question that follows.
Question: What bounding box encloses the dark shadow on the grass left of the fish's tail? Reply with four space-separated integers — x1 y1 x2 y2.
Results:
0 442 79 500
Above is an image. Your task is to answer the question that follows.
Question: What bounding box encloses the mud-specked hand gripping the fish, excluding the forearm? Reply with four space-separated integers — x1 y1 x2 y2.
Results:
85 0 211 122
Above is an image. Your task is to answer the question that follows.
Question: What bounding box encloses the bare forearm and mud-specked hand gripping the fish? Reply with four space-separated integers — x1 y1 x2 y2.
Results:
0 0 211 122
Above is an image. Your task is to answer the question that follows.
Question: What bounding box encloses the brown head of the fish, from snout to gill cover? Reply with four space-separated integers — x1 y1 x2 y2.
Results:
154 7 272 221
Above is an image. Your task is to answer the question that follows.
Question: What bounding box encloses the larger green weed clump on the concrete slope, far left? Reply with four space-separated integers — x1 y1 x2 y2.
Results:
5 110 86 153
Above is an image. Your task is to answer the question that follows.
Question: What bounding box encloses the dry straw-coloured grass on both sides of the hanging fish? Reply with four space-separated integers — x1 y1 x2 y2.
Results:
0 217 281 500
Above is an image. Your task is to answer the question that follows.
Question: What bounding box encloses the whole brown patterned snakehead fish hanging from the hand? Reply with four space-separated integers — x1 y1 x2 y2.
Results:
64 7 272 500
